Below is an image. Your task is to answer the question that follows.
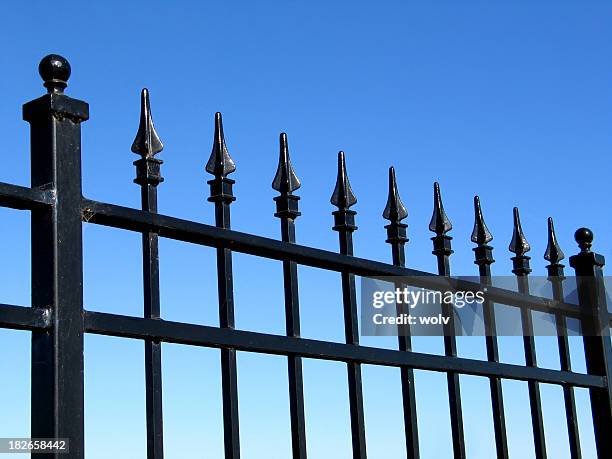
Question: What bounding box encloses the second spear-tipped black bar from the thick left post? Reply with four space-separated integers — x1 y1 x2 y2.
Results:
206 112 240 459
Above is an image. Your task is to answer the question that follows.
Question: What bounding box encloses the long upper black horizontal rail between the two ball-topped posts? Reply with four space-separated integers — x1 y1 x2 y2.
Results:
82 199 581 319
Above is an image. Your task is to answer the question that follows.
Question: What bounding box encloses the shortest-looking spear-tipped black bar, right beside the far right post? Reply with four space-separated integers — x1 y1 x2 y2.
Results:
544 217 582 459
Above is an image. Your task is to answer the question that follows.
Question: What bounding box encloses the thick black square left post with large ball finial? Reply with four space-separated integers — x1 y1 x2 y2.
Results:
23 54 89 459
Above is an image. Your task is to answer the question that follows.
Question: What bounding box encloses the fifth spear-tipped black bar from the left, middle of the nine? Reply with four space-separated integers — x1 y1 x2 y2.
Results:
383 167 420 459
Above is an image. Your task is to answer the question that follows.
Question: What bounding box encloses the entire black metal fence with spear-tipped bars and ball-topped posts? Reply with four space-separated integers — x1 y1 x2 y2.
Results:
0 55 612 459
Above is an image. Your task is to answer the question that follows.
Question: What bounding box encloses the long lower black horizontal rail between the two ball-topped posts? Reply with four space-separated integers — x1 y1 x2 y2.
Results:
85 311 606 388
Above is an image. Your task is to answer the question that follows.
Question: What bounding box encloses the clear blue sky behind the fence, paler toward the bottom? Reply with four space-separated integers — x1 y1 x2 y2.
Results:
0 0 612 459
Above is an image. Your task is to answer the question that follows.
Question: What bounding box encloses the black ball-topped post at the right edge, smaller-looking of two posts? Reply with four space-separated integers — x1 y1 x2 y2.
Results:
570 228 612 459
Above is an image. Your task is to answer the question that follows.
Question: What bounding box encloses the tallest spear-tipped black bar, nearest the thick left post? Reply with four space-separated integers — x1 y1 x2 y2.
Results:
132 88 164 459
